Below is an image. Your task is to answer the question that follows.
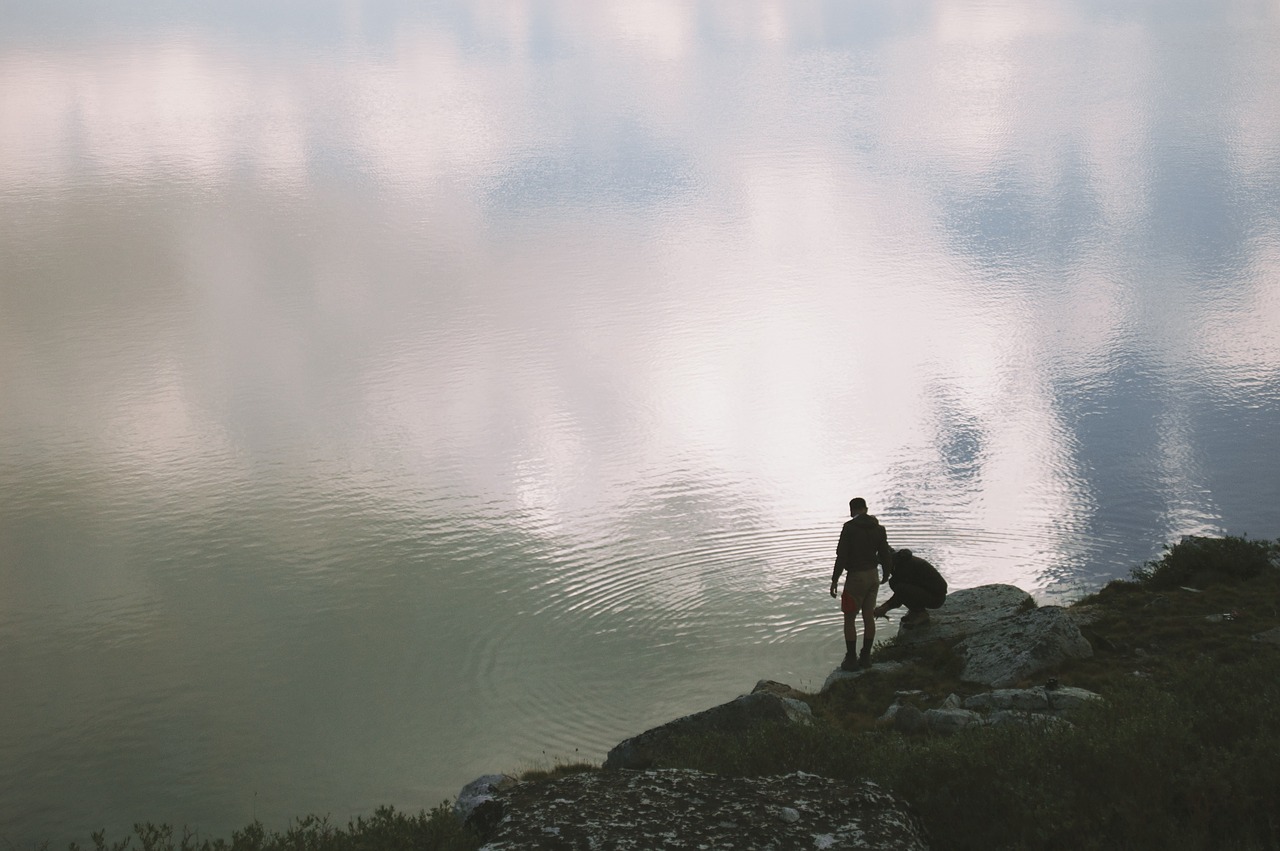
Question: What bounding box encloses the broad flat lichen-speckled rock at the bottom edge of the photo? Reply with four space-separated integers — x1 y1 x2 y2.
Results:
471 769 928 851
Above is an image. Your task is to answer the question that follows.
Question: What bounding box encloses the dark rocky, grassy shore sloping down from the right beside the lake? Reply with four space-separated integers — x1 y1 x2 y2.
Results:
451 536 1280 851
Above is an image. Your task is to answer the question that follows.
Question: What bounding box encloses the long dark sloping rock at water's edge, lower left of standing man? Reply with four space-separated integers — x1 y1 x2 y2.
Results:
604 691 813 769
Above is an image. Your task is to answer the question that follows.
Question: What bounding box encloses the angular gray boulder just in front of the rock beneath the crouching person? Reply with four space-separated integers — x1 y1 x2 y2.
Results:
956 605 1093 688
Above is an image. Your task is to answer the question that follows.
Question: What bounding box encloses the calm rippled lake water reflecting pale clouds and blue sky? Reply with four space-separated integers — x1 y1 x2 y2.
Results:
0 0 1280 847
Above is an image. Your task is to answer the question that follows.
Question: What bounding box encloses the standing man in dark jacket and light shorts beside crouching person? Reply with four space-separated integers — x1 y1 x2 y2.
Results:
831 497 893 671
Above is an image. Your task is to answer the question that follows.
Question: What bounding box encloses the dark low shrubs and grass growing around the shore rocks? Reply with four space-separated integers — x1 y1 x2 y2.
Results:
40 537 1280 851
